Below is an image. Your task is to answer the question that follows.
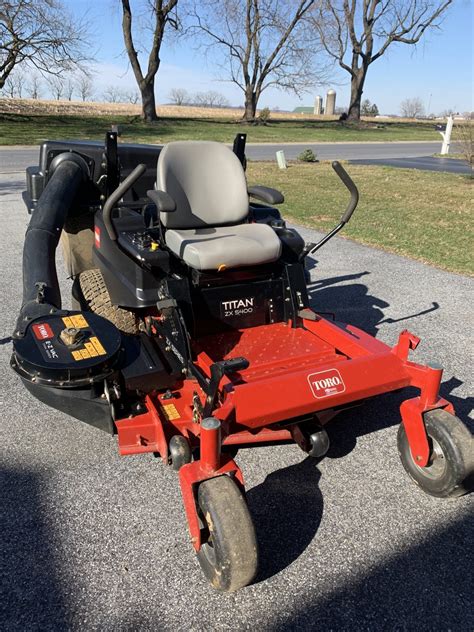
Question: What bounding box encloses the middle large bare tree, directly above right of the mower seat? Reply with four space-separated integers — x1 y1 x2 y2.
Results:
190 0 318 121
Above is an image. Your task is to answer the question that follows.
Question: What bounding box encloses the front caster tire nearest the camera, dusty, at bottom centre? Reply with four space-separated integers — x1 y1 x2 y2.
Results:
197 476 258 592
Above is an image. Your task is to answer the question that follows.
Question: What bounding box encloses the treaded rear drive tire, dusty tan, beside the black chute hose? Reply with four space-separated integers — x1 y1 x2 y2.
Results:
73 268 139 334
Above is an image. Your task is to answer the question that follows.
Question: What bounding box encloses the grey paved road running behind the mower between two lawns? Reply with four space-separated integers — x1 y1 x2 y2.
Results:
0 141 441 173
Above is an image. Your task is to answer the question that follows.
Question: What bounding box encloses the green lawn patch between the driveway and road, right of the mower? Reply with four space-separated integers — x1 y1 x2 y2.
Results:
248 162 474 275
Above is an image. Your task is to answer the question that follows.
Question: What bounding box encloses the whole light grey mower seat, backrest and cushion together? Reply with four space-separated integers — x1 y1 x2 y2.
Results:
156 141 281 270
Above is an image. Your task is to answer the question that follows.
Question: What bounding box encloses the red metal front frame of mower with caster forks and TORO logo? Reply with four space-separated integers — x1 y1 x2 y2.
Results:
115 310 454 550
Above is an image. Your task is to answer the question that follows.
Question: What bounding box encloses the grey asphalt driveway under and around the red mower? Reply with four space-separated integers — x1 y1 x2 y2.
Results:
0 173 474 632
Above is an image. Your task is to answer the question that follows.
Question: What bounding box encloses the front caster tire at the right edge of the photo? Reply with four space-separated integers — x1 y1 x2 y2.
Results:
397 409 474 498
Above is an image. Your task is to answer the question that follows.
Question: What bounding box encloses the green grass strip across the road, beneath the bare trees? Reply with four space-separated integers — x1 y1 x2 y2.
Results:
0 113 439 145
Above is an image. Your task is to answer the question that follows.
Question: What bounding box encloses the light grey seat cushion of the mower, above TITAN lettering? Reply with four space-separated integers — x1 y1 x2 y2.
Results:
165 224 281 270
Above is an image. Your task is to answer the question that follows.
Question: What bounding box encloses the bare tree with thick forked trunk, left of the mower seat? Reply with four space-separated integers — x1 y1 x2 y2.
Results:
122 0 178 122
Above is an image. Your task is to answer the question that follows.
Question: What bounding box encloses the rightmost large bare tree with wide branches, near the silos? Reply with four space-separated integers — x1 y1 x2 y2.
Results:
314 0 453 120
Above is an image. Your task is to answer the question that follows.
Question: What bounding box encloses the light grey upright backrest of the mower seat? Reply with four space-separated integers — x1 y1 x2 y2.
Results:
156 141 249 228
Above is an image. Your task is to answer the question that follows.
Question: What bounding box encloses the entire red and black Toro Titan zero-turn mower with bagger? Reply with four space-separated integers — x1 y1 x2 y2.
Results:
11 133 474 591
